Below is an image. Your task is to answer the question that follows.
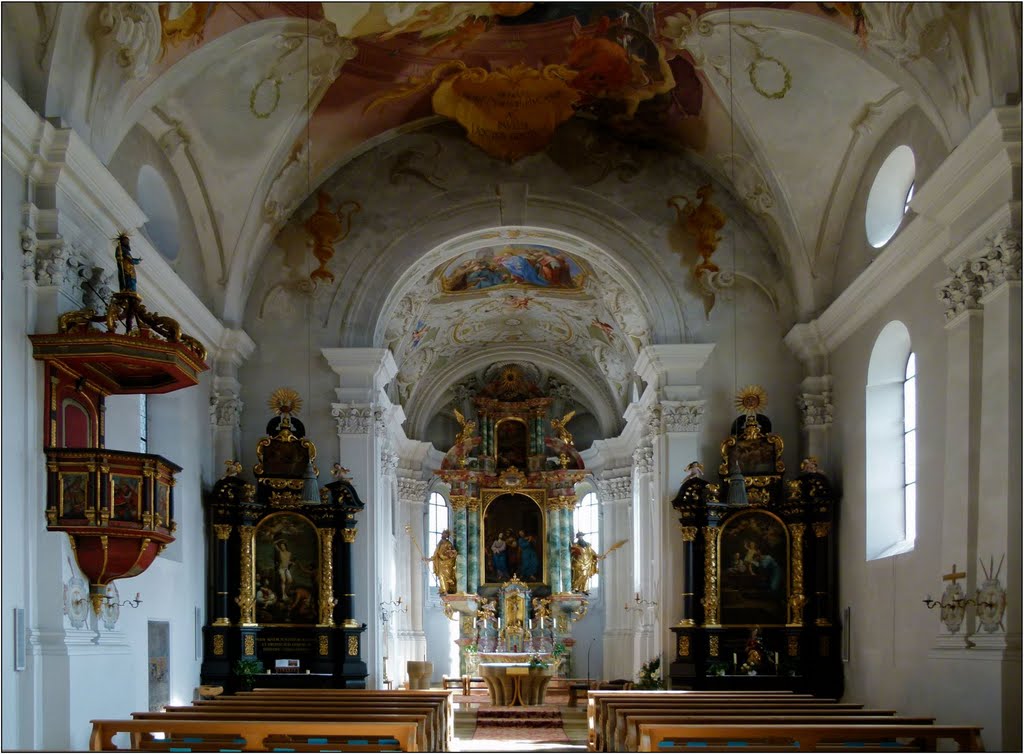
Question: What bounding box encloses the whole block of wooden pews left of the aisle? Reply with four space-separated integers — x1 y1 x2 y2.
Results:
90 689 454 752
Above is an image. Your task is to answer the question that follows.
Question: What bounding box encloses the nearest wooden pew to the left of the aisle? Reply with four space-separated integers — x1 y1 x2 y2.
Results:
89 719 419 752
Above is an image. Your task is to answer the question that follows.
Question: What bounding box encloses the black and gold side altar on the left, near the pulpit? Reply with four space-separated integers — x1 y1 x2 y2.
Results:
202 412 368 692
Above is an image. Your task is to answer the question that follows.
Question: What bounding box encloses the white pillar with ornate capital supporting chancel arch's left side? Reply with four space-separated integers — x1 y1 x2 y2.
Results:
322 348 400 688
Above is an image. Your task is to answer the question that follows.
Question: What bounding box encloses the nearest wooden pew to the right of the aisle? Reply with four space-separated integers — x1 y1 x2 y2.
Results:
640 723 983 752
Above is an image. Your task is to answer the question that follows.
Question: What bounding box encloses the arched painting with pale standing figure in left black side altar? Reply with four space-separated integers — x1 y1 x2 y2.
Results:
254 513 319 625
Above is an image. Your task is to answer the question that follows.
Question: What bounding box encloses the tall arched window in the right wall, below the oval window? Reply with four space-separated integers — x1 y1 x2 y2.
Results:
864 322 918 560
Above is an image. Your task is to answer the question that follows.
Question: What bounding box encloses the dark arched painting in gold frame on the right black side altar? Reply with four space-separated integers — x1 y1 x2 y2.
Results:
719 510 790 626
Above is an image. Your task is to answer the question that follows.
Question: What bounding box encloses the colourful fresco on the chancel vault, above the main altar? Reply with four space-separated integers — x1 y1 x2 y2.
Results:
440 244 586 293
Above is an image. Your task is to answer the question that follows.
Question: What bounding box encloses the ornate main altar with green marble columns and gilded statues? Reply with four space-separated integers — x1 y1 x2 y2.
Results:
432 365 593 676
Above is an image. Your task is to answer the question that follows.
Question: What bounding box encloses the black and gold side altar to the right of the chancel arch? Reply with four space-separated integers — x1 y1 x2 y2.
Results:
670 414 843 699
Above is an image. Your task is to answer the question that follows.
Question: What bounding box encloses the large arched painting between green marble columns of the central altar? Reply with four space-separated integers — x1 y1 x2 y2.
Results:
480 493 545 584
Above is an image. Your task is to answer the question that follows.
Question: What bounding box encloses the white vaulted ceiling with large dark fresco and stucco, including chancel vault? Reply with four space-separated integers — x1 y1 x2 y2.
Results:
3 2 1020 442
